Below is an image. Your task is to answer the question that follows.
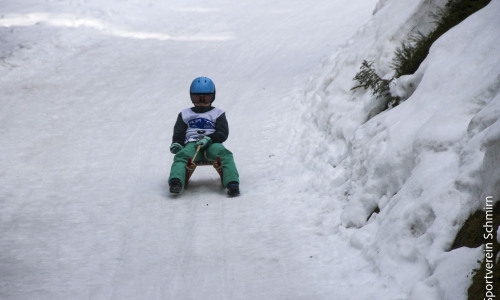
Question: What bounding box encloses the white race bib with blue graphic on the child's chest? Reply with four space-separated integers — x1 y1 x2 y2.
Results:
181 107 224 144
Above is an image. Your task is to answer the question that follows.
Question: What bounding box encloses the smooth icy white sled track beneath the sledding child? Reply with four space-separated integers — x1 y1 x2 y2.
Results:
0 0 398 299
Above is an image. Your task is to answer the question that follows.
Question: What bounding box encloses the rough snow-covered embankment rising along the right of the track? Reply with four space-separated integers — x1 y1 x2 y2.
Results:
294 0 500 299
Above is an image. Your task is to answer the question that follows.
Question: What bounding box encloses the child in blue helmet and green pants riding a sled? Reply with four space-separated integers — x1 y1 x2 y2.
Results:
168 77 240 196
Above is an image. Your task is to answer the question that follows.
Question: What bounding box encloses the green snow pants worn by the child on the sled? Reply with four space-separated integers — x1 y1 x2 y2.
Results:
168 142 240 186
